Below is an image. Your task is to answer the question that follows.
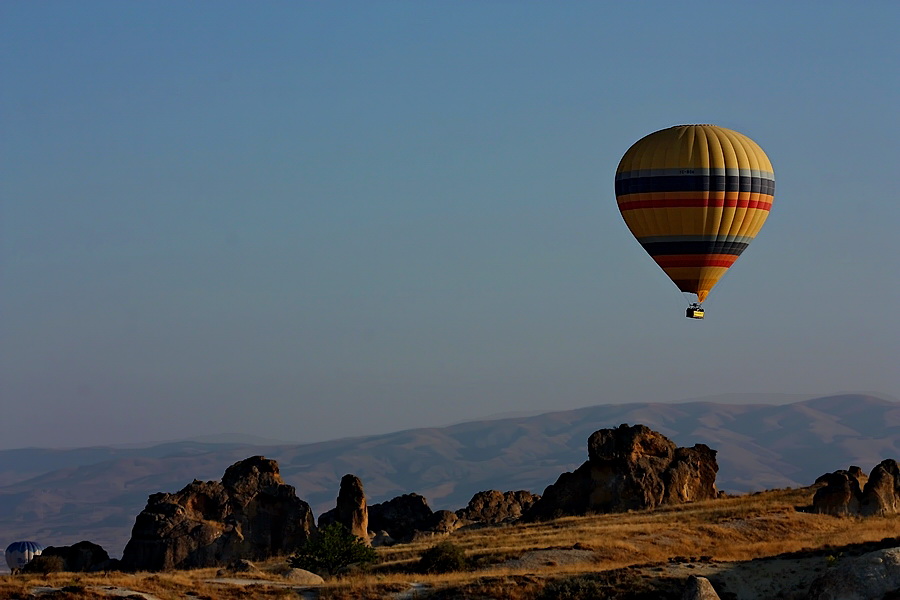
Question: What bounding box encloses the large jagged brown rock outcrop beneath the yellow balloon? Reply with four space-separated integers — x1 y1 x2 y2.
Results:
525 425 719 520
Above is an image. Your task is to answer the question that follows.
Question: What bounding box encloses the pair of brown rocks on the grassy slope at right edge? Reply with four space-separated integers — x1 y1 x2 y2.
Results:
813 459 900 516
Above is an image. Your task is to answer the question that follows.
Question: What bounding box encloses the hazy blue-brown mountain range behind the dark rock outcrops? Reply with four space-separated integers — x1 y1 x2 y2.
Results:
0 394 900 556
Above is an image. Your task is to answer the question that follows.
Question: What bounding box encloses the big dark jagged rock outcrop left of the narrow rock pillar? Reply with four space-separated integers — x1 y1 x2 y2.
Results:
122 456 315 571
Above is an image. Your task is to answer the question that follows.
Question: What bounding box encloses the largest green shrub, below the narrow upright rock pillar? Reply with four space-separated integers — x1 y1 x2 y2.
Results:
288 523 378 575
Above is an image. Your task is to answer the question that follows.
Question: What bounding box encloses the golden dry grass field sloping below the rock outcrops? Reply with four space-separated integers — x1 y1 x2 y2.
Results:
0 488 900 600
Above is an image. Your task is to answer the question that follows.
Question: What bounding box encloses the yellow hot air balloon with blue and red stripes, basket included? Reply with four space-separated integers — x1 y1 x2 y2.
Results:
616 125 775 319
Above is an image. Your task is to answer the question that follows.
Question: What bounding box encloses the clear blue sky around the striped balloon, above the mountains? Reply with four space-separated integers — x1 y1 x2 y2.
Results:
0 0 900 447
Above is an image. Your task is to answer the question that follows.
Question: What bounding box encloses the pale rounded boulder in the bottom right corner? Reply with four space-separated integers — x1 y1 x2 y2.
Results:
807 548 900 600
